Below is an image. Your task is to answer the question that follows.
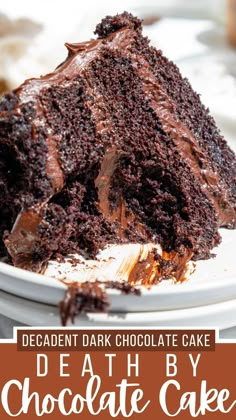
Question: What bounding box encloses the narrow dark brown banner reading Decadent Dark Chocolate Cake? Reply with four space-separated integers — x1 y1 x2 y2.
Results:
17 329 215 351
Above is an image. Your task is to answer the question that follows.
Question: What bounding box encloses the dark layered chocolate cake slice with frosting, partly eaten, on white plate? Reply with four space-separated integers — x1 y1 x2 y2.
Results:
0 12 236 280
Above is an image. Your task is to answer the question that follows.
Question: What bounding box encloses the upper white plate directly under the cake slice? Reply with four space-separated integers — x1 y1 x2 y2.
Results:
0 226 236 312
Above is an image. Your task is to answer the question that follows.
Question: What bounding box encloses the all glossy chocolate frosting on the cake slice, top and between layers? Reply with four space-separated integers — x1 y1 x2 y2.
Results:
5 13 236 277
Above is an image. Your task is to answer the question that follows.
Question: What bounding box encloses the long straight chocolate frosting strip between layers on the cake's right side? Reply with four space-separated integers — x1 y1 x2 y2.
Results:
130 55 236 226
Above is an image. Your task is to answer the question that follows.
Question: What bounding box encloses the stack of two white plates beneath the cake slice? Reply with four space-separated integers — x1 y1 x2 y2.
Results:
0 230 236 329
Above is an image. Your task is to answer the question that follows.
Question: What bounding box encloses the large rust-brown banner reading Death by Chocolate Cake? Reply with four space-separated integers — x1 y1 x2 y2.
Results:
0 329 236 420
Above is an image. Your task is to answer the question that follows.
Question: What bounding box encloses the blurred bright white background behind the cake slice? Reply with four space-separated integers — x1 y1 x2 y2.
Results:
0 0 236 132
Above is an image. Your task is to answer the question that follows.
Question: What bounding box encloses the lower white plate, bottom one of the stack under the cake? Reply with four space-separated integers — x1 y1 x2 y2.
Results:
0 292 236 329
